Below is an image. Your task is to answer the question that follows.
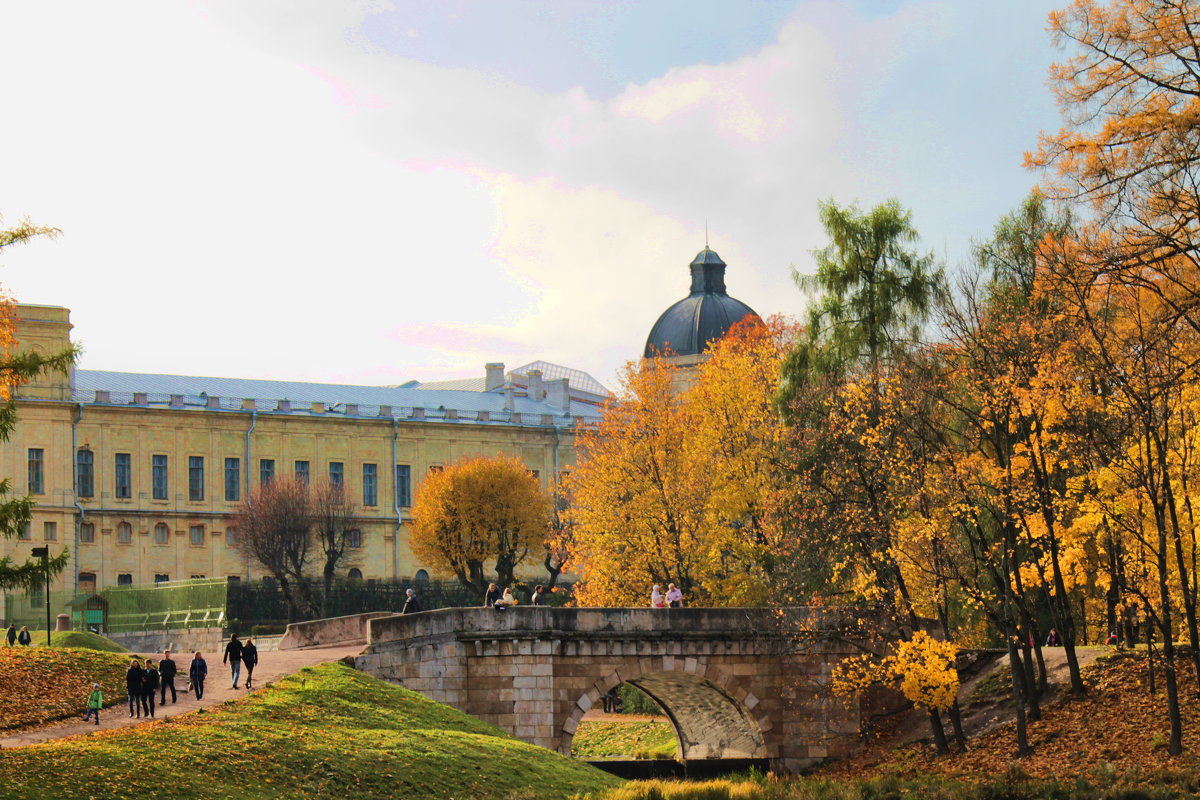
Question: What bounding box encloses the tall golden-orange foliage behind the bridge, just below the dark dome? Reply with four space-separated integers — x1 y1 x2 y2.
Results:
568 319 796 606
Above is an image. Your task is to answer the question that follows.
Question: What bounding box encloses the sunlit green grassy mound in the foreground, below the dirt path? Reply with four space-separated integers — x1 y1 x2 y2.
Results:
0 664 619 800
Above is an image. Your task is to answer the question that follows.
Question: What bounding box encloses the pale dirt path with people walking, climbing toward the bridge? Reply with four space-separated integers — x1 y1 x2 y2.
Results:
0 644 362 748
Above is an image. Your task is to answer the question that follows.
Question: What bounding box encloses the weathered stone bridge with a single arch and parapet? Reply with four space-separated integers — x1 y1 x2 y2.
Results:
356 606 899 771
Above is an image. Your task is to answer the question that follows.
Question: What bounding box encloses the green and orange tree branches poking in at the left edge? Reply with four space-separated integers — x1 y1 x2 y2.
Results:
0 221 79 590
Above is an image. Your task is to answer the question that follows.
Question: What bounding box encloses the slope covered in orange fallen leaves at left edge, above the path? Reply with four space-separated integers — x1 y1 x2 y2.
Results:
0 646 128 730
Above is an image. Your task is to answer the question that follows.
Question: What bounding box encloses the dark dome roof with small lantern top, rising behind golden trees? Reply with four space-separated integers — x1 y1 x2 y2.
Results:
646 247 758 359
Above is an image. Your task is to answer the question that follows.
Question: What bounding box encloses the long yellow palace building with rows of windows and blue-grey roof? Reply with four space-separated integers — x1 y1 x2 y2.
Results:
0 305 607 604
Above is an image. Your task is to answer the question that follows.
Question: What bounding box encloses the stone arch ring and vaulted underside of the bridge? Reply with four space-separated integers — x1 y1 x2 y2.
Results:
558 656 778 760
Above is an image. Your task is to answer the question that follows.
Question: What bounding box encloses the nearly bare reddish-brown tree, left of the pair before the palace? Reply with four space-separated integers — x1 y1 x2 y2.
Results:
238 476 317 621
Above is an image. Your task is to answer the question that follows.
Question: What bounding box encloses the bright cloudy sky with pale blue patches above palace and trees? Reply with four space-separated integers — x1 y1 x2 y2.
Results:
0 0 1064 386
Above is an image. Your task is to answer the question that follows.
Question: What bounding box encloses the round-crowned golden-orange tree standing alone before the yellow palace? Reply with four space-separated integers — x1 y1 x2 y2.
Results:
409 456 553 597
